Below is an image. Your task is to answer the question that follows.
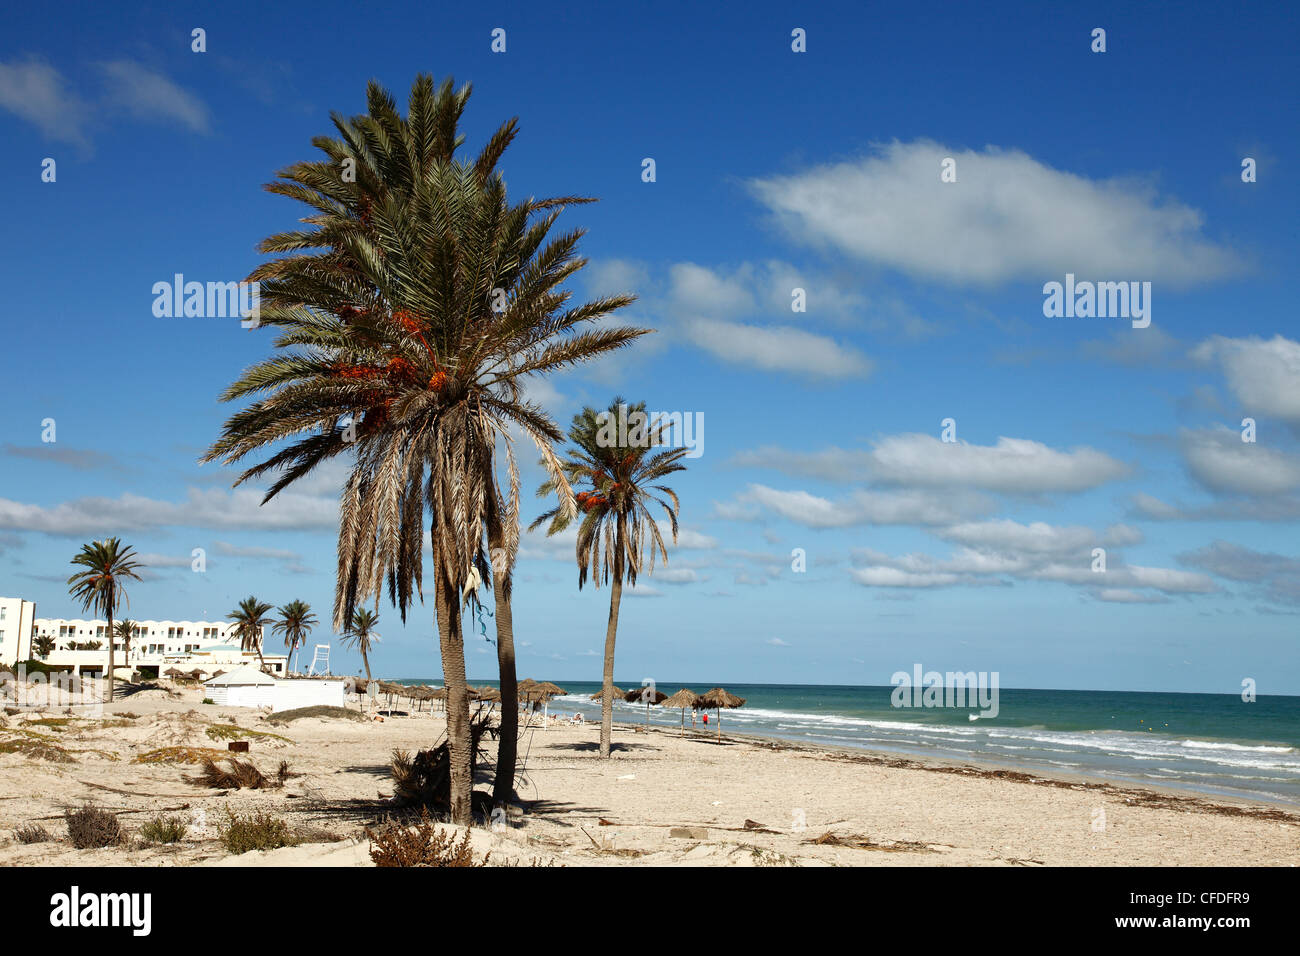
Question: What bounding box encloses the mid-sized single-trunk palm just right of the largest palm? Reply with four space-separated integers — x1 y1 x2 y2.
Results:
529 398 689 757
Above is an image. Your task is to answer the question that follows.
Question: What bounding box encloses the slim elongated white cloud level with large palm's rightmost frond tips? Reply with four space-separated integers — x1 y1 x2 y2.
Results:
685 319 874 378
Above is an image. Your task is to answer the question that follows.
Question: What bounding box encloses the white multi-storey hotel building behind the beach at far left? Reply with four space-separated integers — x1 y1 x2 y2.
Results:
0 597 289 678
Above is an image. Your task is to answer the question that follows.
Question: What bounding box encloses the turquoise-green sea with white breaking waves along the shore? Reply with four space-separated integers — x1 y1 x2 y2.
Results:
398 679 1300 805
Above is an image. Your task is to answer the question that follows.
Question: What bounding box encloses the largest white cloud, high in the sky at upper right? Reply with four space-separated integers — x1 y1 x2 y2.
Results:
750 140 1240 284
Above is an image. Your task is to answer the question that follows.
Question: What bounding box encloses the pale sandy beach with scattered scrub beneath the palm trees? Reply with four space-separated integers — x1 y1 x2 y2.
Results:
0 688 1300 866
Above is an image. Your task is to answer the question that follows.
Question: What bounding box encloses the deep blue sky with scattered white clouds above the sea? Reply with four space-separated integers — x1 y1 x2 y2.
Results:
0 1 1300 695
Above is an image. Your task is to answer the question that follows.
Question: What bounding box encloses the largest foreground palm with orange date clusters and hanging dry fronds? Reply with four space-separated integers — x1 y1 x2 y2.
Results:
204 75 647 823
